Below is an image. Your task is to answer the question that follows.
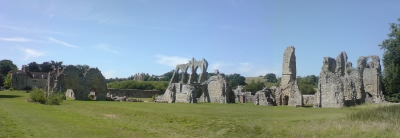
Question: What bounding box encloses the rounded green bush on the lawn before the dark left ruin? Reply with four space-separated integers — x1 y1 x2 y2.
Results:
29 89 64 105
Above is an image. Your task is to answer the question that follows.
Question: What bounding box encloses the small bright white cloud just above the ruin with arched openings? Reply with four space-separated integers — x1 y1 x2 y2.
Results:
156 55 190 67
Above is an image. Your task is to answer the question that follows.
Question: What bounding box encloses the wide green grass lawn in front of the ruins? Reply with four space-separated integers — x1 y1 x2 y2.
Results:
0 91 400 138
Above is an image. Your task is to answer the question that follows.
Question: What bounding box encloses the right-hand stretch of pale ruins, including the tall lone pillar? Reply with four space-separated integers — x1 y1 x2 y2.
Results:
234 46 385 108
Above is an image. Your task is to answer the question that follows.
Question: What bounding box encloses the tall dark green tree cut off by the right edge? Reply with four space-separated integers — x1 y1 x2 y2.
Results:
379 18 400 102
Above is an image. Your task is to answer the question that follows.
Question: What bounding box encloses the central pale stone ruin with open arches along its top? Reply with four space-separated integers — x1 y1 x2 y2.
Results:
156 58 235 103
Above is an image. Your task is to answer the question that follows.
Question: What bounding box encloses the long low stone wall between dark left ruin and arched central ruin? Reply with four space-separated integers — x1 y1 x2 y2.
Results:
107 88 163 98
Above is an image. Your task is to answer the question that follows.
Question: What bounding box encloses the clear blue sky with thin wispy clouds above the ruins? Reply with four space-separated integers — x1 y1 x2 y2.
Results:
0 0 400 78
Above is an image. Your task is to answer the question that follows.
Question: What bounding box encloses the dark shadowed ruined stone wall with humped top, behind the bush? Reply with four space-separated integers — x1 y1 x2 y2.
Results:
46 65 107 100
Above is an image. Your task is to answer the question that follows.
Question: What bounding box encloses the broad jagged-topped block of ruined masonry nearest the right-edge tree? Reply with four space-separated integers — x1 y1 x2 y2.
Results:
314 52 384 108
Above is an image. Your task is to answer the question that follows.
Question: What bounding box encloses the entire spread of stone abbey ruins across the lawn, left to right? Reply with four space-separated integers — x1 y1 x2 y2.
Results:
7 46 385 108
